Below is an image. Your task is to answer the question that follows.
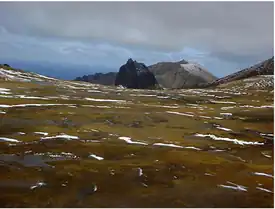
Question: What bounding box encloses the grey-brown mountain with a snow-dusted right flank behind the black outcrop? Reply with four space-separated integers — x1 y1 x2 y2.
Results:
149 60 216 89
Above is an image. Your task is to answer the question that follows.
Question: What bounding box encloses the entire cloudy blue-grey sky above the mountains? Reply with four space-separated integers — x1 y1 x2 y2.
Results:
0 2 274 77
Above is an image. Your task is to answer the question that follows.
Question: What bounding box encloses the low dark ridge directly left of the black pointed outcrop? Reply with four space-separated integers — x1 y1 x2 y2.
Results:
75 72 117 86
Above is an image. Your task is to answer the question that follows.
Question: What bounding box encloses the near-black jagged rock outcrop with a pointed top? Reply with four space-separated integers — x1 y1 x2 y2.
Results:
115 59 157 89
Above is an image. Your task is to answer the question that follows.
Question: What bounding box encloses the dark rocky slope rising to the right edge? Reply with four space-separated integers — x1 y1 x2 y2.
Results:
202 57 274 87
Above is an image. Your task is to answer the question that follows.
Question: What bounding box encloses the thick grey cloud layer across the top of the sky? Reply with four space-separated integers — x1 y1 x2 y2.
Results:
0 2 274 56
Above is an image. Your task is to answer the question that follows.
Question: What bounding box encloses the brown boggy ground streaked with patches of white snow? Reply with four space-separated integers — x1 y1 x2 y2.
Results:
0 81 274 207
